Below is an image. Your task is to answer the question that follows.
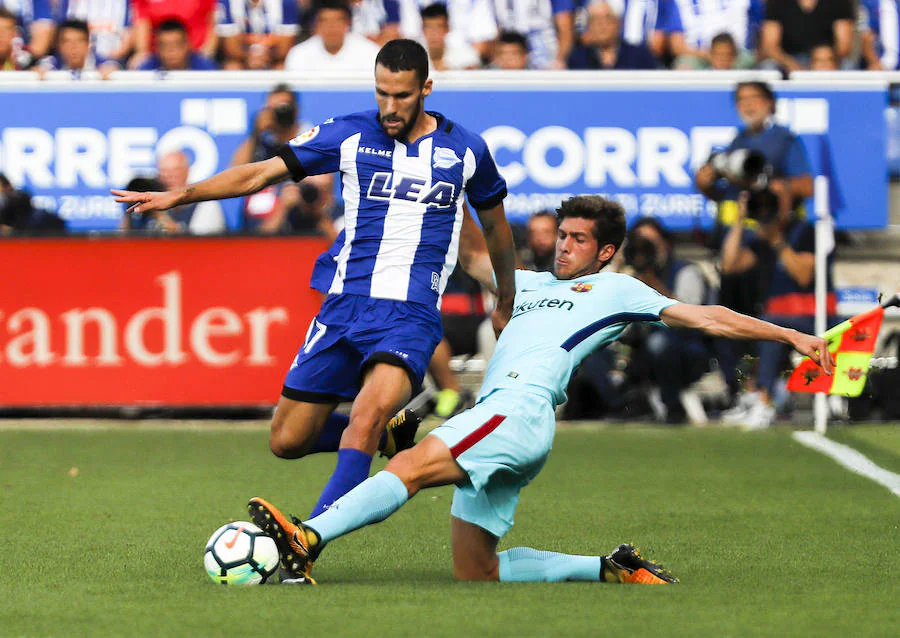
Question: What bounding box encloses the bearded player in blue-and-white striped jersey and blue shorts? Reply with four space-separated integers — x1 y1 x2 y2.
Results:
112 40 515 556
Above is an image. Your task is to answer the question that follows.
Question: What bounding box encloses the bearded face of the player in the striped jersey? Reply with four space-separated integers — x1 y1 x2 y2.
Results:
375 64 431 140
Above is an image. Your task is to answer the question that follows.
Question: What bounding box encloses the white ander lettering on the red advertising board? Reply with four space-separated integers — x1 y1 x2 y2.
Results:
0 271 288 368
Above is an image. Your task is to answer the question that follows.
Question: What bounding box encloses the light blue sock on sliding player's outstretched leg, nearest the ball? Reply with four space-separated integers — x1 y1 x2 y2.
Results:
304 471 412 544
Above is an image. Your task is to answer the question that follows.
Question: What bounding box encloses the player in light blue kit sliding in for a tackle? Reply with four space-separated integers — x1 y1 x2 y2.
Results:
248 196 834 584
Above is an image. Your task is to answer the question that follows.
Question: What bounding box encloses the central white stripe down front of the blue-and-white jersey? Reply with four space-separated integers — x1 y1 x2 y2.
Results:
370 137 434 301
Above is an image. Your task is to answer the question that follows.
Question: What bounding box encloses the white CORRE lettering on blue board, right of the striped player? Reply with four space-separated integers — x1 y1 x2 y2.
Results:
482 126 737 189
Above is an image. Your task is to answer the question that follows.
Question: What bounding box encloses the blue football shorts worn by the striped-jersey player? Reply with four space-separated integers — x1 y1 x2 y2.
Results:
281 294 443 403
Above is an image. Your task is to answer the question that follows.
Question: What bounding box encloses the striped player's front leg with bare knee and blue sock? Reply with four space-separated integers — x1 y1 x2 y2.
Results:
310 363 412 518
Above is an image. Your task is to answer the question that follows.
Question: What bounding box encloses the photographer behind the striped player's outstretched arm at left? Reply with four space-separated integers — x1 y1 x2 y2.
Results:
231 84 334 237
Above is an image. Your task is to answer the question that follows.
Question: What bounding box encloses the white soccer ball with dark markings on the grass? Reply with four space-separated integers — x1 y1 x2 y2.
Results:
203 521 278 585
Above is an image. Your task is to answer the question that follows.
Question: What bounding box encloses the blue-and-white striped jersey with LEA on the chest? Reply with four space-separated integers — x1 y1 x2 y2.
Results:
279 110 506 306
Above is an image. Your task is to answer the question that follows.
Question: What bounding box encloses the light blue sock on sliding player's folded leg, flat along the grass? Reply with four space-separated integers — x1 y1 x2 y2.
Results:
498 547 601 583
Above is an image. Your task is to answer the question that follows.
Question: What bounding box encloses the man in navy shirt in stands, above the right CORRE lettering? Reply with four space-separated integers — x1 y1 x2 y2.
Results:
569 2 658 70
